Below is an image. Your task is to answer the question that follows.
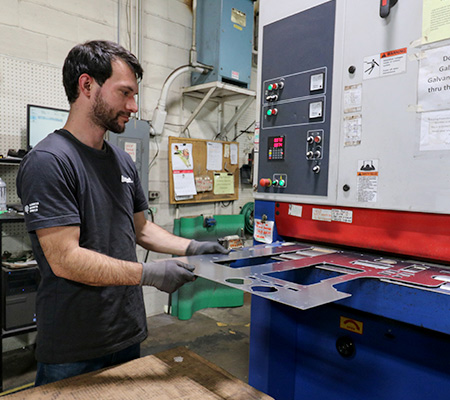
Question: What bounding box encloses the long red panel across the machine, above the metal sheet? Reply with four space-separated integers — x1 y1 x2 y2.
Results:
275 203 450 262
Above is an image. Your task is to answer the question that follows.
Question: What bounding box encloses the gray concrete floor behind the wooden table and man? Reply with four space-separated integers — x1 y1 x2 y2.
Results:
3 293 250 392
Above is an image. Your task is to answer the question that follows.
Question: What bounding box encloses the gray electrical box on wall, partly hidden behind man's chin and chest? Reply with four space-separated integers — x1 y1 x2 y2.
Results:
108 119 150 198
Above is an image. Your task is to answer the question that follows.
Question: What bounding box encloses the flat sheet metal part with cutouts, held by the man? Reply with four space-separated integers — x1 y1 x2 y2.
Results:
180 243 450 310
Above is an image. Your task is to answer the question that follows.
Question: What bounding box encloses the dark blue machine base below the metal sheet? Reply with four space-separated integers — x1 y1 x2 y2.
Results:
249 296 450 400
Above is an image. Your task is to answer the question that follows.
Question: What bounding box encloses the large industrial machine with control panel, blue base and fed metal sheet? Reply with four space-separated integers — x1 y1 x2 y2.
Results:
178 0 450 400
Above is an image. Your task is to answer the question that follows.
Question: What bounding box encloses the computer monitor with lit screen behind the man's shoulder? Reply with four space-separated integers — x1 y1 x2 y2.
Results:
27 104 69 150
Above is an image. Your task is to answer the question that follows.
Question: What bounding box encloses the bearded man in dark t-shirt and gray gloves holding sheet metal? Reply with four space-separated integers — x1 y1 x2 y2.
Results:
17 41 226 386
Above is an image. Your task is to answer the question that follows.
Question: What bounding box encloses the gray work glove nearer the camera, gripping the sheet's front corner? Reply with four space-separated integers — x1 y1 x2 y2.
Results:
139 258 195 293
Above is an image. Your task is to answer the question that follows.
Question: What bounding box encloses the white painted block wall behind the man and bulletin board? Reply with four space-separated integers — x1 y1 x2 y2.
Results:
0 0 256 350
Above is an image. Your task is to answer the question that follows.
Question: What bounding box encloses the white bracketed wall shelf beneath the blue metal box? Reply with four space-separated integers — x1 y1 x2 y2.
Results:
181 82 256 136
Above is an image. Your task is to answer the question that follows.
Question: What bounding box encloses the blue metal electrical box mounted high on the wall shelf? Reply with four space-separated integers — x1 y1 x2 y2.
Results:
191 0 253 88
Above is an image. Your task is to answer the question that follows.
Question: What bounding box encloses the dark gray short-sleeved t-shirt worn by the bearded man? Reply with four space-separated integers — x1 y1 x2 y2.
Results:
17 130 148 363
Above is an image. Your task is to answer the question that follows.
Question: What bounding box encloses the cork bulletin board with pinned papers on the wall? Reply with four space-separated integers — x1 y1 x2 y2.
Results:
168 136 239 204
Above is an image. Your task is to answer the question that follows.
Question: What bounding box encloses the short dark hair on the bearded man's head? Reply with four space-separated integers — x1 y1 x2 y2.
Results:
63 40 144 104
